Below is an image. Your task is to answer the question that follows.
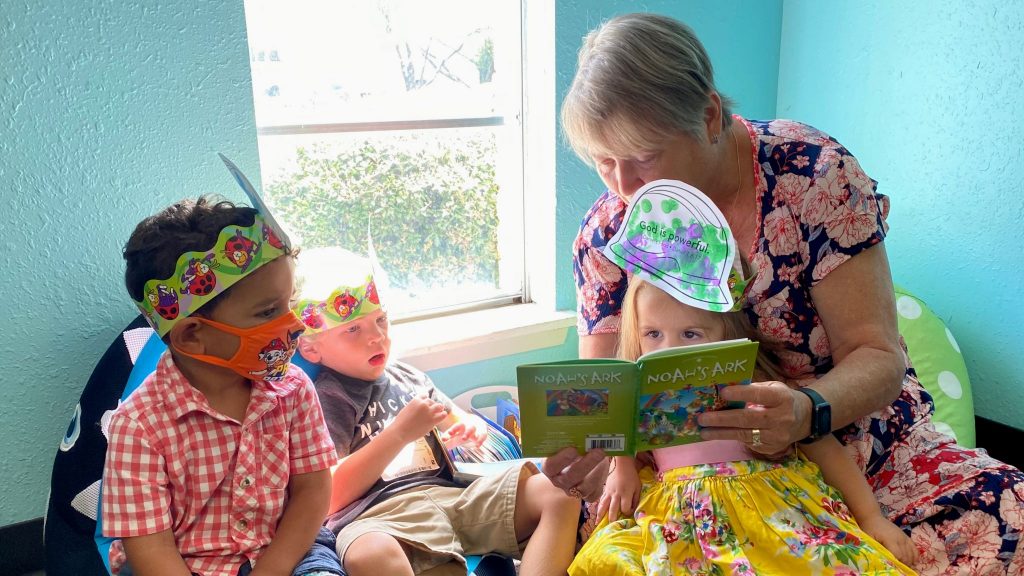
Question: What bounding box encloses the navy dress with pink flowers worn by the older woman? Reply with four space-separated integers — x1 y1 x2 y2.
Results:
573 116 1024 575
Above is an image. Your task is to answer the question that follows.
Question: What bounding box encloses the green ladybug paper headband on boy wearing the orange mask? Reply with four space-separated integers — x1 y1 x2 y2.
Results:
135 155 291 337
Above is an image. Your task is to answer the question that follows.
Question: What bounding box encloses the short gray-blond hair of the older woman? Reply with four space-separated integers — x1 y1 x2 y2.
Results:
561 13 732 163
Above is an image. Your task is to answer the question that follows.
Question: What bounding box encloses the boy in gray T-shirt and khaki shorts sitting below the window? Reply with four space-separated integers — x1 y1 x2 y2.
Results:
293 248 580 576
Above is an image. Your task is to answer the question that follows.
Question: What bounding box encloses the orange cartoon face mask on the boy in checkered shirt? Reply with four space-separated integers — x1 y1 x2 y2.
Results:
175 312 306 382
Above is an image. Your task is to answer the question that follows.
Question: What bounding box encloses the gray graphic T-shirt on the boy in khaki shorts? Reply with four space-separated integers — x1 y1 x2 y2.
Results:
315 362 462 533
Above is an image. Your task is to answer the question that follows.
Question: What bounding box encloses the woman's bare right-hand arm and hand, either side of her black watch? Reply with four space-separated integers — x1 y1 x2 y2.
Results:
699 244 906 454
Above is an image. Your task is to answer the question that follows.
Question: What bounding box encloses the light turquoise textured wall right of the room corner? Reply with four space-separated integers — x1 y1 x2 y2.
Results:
778 0 1024 428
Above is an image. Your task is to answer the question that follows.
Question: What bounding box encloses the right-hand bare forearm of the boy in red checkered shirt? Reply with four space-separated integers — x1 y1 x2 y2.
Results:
251 468 331 576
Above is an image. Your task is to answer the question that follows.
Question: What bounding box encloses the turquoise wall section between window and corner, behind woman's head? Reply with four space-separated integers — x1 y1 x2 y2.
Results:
555 0 782 310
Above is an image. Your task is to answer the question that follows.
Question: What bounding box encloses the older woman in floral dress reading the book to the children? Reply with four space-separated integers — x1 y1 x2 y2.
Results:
545 14 1024 574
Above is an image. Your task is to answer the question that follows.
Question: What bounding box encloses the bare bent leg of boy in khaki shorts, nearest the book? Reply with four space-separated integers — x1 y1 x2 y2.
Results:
515 474 580 576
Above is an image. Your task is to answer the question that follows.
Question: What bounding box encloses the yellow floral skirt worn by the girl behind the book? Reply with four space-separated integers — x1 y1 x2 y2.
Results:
569 456 914 576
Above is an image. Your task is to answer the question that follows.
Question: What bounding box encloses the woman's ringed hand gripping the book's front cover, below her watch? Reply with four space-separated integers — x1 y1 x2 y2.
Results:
698 381 811 456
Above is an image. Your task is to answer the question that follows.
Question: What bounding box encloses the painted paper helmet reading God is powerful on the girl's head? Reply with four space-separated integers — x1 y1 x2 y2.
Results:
602 180 749 312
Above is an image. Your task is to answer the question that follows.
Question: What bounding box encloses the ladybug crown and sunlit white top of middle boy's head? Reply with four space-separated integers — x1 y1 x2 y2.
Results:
292 247 383 334
